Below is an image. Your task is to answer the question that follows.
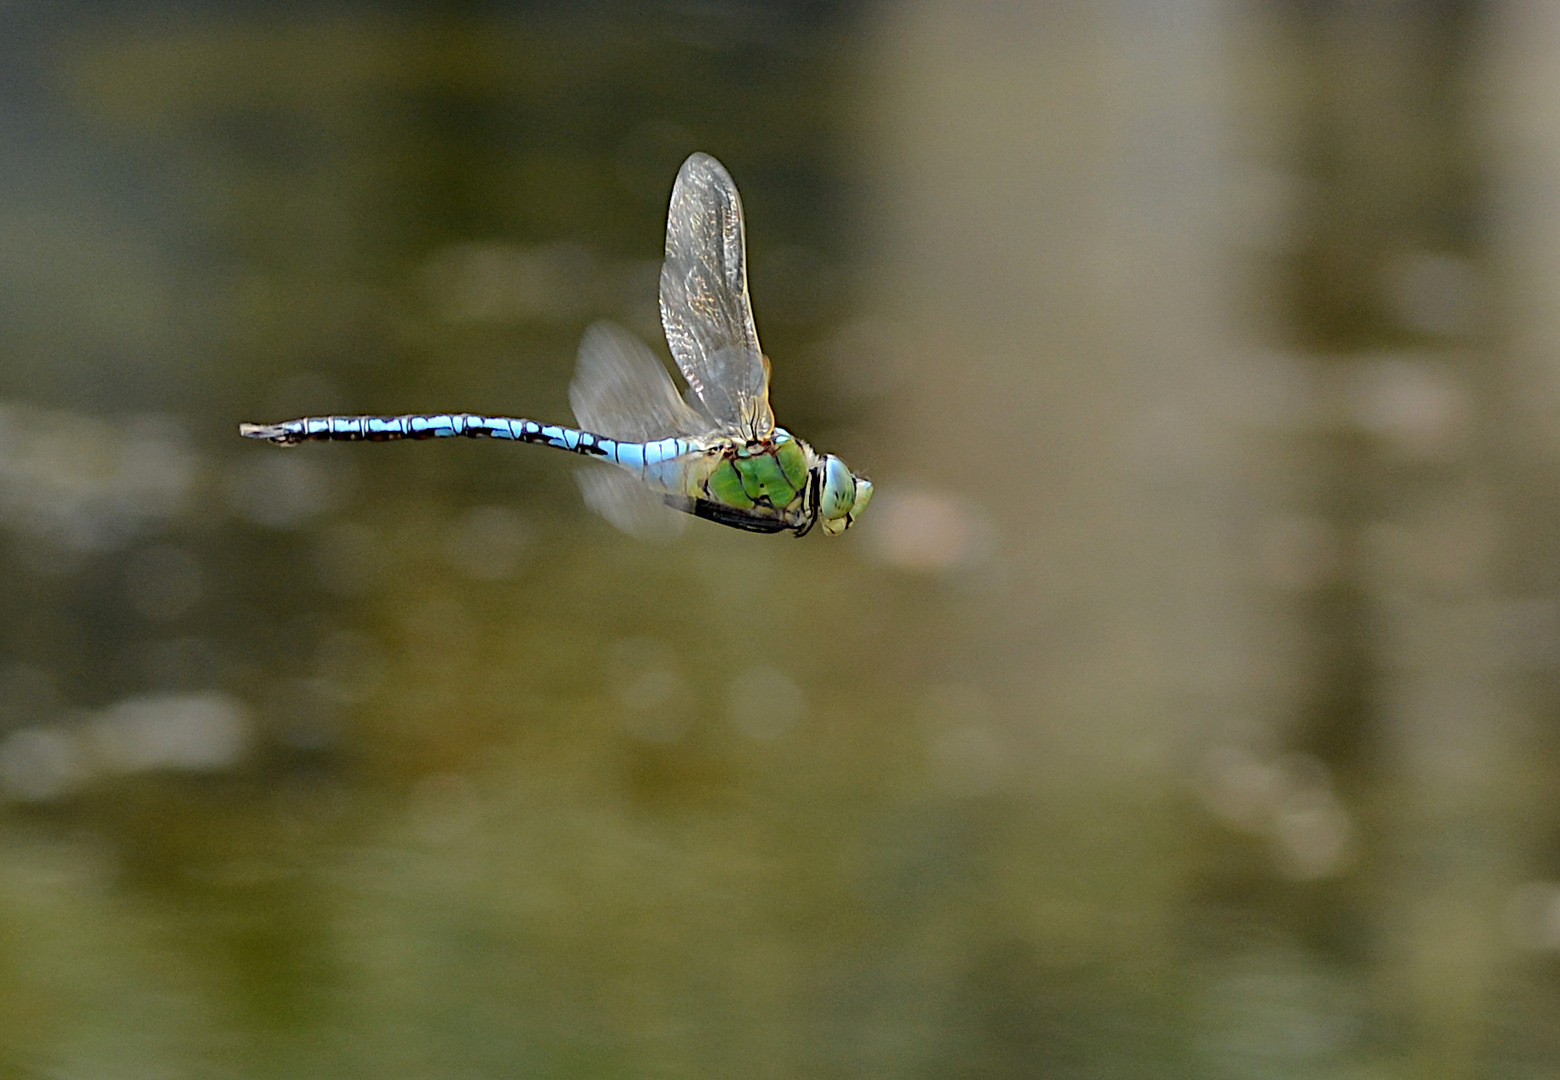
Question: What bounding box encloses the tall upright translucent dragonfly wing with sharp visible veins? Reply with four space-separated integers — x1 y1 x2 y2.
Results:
661 153 774 439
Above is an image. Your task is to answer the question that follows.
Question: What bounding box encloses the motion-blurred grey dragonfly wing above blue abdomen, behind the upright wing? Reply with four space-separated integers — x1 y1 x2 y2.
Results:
569 323 710 443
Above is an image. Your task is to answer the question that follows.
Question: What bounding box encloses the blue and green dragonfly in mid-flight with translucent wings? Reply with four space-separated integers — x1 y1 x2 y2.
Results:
239 153 872 537
